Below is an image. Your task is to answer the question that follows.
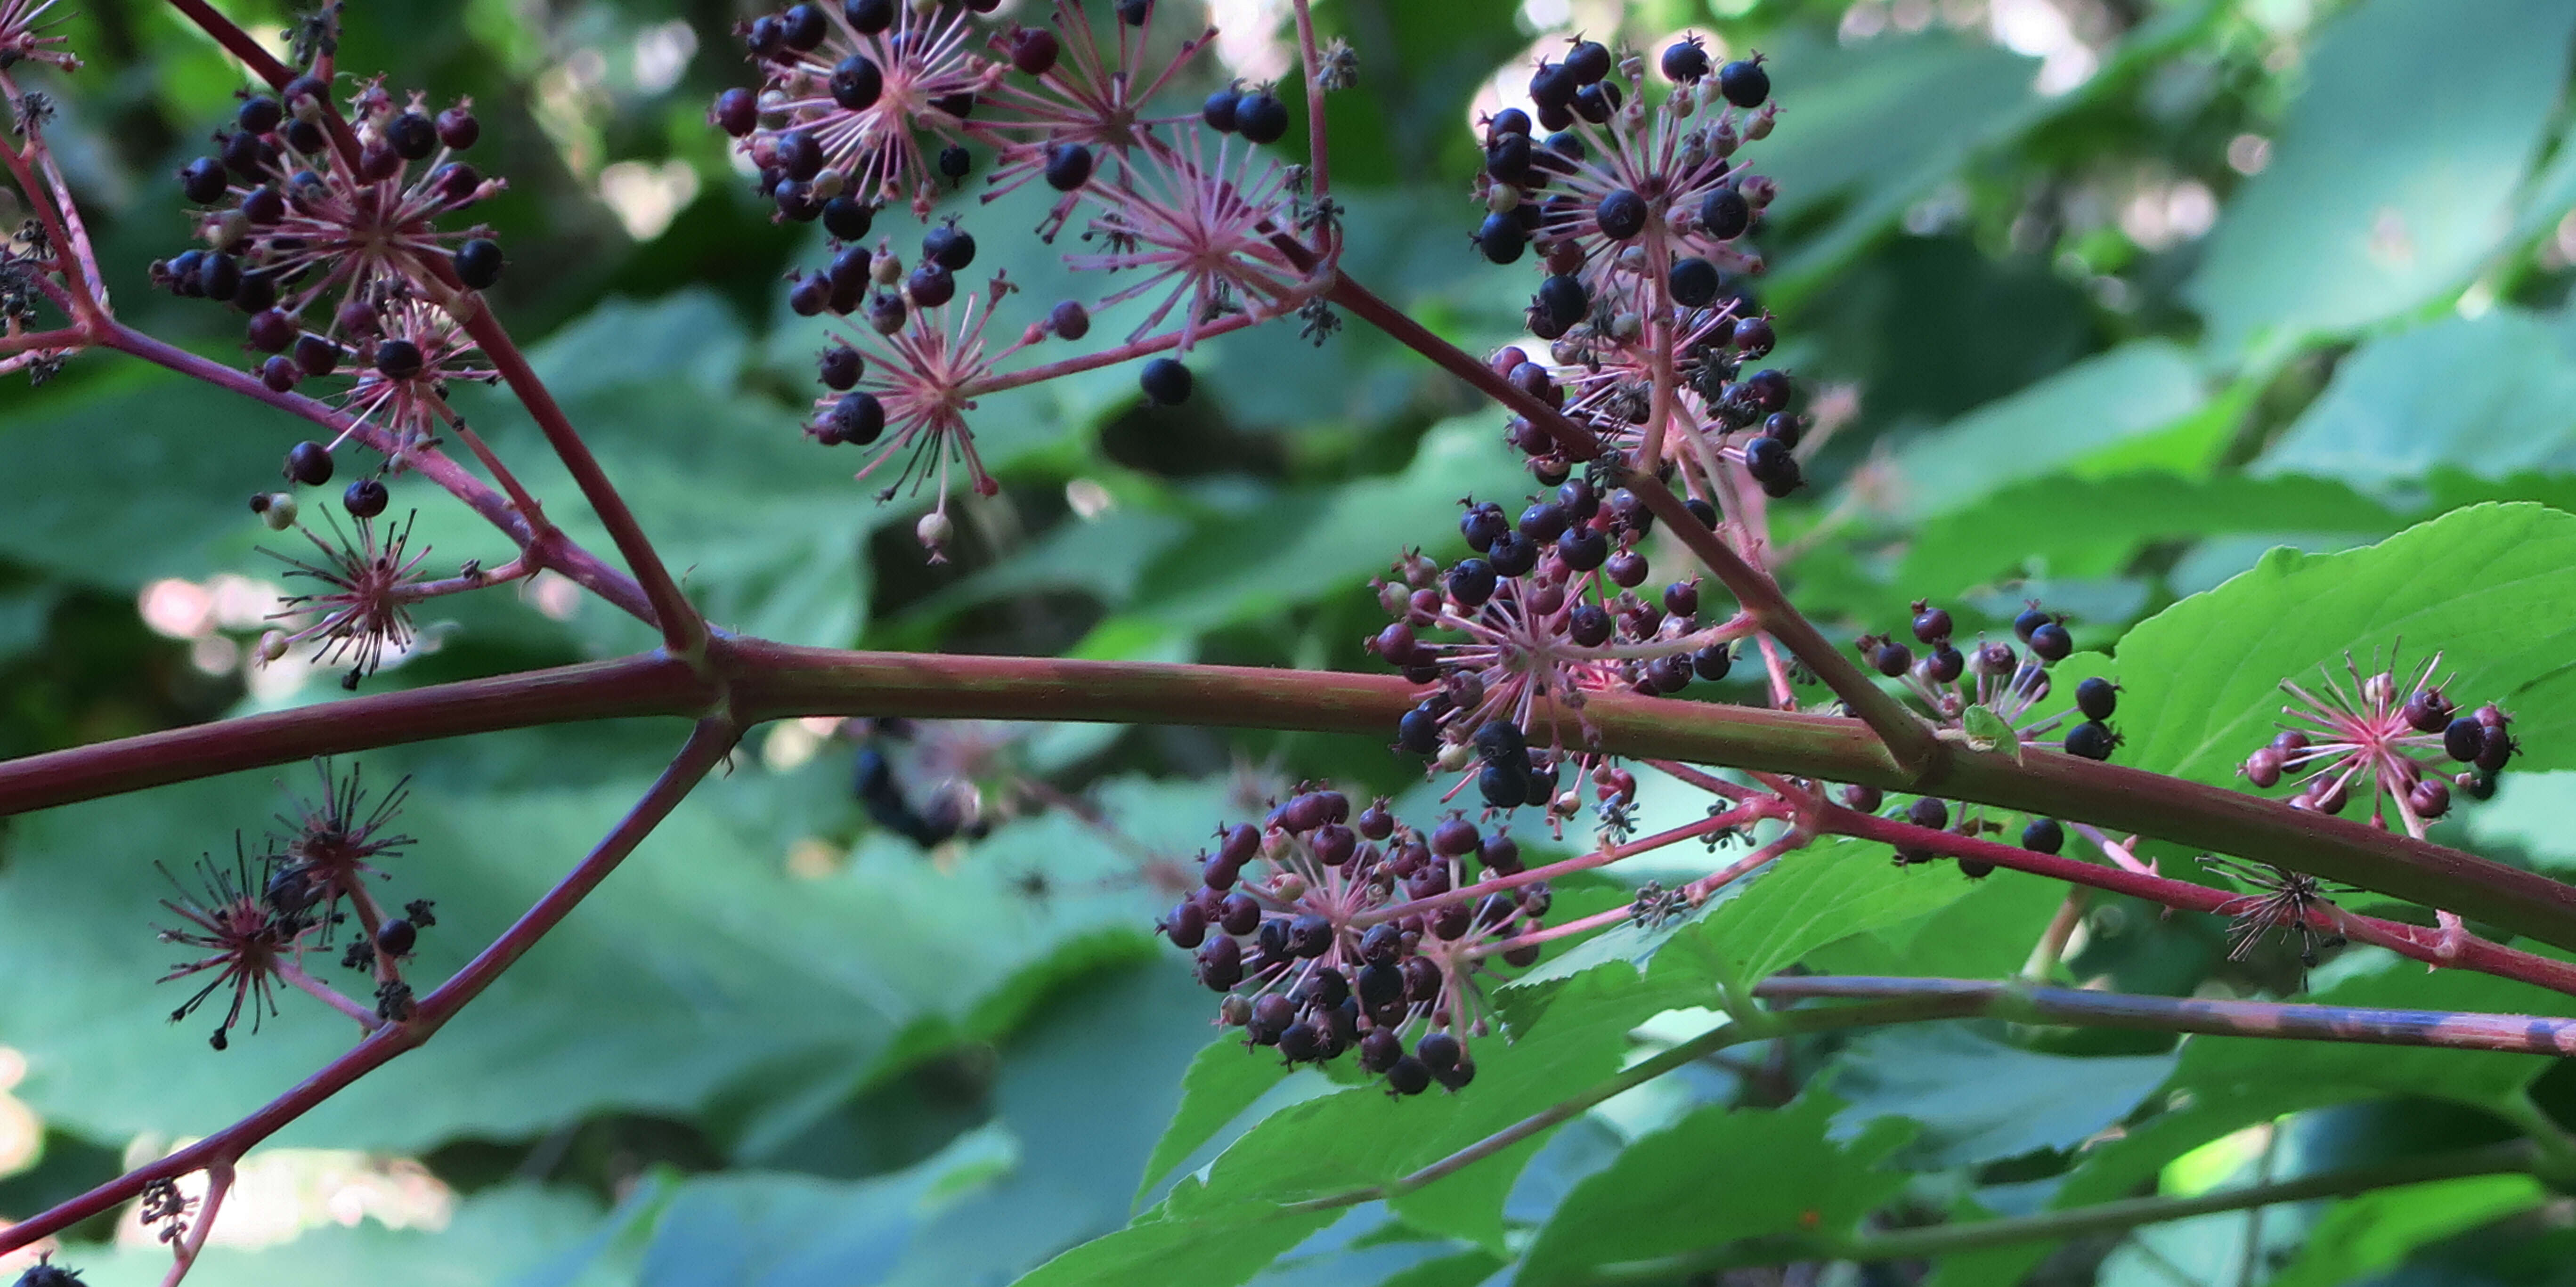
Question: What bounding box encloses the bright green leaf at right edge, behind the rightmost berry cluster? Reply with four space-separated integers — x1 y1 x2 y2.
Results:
2105 504 2576 783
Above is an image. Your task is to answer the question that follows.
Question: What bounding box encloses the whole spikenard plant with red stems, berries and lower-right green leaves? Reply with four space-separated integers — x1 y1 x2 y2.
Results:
0 0 2576 1287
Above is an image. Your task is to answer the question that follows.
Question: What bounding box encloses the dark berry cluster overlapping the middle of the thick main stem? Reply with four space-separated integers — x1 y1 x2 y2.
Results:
1368 479 1752 816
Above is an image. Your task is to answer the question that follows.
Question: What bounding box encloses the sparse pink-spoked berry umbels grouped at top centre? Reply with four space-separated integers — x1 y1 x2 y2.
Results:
708 0 1324 561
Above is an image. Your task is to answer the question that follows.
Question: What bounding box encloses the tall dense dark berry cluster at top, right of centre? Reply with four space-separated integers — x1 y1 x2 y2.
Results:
1473 36 1806 510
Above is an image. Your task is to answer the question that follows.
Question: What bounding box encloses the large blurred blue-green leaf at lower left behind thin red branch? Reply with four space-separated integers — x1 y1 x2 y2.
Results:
0 757 1195 1153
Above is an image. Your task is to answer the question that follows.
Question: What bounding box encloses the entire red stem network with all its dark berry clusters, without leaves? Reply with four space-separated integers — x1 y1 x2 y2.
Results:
0 0 2576 1266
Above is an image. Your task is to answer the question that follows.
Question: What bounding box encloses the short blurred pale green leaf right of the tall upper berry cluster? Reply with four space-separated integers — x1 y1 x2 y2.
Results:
1891 340 2208 523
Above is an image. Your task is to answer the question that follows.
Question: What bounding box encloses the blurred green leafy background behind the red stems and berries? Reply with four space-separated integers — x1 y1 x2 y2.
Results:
0 0 2576 1287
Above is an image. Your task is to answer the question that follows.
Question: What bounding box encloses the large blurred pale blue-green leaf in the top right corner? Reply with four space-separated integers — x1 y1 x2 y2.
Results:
2185 0 2576 358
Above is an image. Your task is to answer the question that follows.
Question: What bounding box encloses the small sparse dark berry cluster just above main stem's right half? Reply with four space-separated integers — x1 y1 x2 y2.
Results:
1852 600 2120 759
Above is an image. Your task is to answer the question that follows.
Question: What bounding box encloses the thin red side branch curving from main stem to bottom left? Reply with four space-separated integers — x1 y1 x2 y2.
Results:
0 720 739 1251
